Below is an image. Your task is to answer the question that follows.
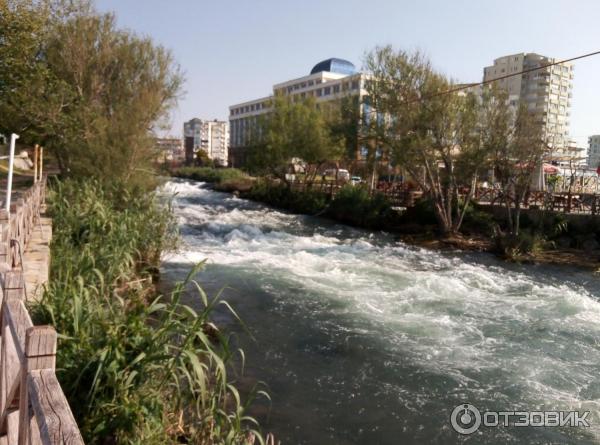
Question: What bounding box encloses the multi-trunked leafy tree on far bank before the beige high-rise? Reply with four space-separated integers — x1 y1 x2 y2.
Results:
366 46 486 235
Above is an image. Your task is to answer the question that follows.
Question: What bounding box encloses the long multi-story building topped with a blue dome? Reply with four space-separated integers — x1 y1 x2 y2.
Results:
229 58 365 166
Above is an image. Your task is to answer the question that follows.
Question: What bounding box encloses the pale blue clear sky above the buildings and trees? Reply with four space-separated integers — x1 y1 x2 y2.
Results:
96 0 600 146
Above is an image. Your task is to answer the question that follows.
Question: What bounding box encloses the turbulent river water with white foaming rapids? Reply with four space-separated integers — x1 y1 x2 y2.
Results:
163 180 600 445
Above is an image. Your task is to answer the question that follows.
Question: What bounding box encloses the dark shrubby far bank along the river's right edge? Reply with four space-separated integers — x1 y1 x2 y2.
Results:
172 168 600 271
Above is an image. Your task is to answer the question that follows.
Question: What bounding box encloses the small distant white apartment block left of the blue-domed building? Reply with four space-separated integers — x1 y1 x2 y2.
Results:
183 118 229 166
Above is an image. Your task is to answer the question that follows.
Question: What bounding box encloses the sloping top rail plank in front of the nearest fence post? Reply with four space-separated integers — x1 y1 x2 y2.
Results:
27 369 83 445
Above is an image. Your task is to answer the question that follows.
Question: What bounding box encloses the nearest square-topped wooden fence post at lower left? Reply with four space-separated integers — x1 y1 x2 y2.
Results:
19 326 56 445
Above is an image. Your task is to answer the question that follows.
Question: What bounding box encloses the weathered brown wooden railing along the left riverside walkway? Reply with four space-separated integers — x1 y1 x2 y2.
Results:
0 180 83 445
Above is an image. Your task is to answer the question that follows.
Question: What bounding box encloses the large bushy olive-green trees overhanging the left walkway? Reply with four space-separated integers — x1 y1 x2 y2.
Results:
0 0 182 182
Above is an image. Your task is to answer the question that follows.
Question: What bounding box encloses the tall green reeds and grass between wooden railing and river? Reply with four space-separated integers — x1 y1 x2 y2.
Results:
31 181 266 444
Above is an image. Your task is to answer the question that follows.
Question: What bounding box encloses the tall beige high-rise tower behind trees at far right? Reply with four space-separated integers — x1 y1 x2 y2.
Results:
483 53 573 150
